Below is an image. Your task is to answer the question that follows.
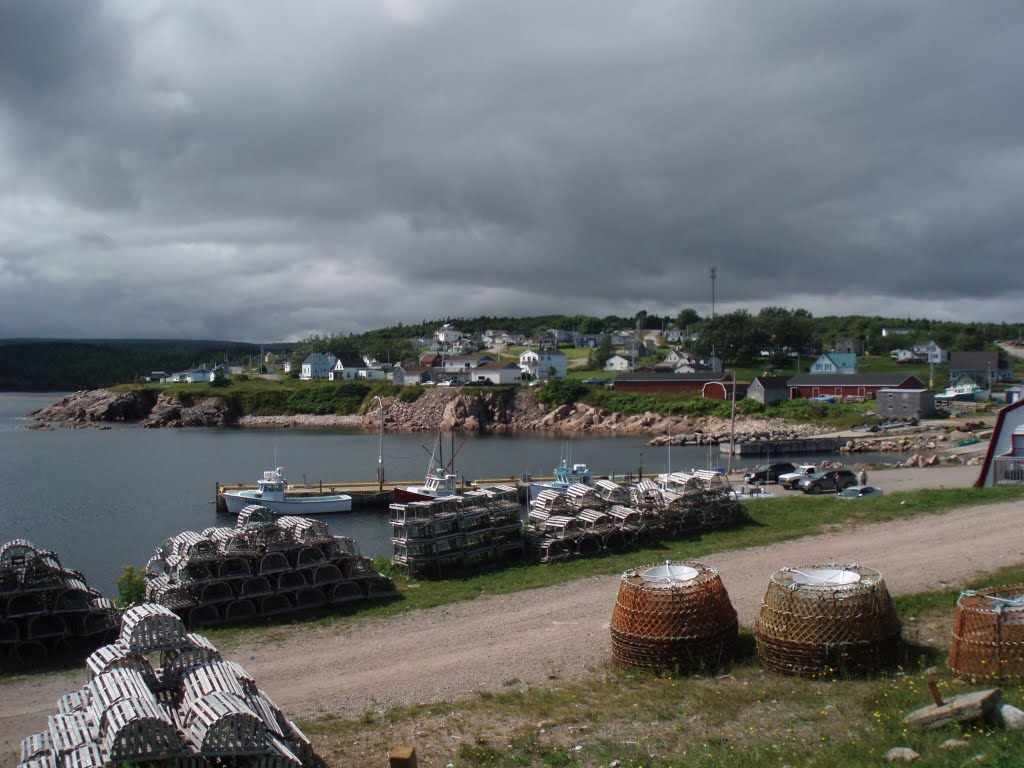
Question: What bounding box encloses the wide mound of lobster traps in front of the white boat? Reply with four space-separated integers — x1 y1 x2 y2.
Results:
145 505 397 626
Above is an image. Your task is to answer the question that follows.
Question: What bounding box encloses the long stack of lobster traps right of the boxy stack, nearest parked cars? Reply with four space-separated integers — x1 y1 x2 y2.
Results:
524 471 744 562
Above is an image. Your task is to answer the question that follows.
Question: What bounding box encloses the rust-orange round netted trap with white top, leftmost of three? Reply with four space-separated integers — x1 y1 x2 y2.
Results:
611 562 738 672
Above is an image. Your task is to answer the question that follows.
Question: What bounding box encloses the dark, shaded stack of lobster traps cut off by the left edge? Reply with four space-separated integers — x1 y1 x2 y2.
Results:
0 539 119 658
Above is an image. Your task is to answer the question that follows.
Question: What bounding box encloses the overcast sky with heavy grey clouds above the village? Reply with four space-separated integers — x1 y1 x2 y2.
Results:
0 0 1024 342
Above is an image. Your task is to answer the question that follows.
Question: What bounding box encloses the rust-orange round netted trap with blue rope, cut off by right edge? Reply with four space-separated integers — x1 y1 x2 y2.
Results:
949 584 1024 682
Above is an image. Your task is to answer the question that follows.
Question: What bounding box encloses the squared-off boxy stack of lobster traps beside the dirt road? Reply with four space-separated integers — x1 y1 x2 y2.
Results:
390 485 523 578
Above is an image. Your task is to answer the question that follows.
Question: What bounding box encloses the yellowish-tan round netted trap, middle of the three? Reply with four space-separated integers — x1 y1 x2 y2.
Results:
754 564 900 677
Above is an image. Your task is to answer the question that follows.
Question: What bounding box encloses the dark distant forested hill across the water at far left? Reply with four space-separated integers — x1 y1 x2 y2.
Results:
0 339 272 392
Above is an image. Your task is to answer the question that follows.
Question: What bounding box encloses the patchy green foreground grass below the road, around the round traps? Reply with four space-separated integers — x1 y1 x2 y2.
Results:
299 565 1024 768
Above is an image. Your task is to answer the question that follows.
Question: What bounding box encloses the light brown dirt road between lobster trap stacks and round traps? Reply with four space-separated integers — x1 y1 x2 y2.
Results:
0 467 1024 766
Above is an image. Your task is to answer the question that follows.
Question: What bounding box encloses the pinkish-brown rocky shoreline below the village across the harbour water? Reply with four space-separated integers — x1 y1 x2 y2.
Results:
28 388 986 466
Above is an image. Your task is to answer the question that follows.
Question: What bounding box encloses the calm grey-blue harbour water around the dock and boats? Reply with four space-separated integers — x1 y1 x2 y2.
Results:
0 393 884 597
